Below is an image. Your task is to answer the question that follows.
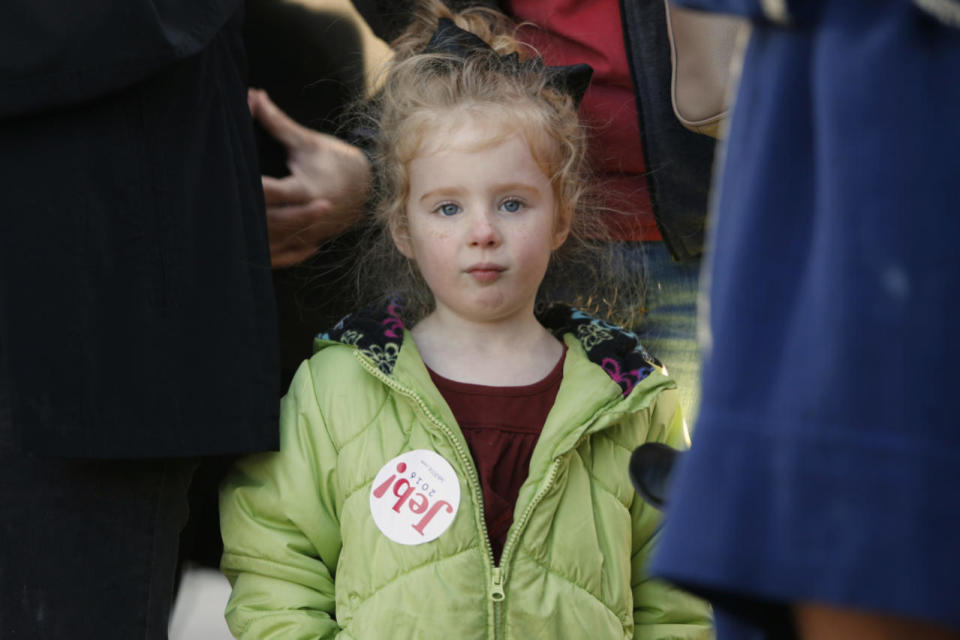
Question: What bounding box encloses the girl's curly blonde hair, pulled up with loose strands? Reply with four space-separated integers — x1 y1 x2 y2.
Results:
359 0 636 322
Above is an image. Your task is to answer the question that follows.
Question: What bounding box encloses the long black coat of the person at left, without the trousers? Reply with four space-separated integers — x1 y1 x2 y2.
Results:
0 0 278 457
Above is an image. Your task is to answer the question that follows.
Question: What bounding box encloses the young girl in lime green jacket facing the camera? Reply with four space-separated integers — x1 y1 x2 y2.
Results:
222 6 710 640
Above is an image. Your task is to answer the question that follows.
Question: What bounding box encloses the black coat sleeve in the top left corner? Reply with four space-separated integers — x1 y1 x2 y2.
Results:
0 0 242 118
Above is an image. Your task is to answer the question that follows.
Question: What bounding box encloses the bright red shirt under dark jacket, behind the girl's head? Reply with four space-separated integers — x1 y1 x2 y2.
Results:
508 0 661 241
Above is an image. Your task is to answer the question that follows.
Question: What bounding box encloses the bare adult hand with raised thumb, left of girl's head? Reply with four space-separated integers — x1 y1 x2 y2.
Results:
247 89 370 268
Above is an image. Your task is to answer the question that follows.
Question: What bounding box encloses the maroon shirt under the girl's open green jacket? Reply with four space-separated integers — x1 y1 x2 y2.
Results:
427 345 567 563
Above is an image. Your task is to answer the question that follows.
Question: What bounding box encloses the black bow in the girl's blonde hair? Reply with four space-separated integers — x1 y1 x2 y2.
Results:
423 18 593 106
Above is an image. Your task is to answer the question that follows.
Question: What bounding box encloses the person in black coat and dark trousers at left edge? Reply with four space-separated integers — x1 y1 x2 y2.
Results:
0 0 279 638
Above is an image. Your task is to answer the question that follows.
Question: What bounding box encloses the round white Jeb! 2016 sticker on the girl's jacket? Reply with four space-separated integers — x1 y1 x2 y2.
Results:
370 449 460 545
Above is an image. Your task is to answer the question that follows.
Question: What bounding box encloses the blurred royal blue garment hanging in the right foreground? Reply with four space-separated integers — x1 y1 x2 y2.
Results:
654 0 960 637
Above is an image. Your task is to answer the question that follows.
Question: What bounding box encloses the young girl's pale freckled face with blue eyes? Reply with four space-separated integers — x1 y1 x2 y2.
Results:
394 121 569 322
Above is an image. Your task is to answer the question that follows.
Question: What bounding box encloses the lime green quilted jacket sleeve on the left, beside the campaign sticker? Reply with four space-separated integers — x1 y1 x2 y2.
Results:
220 363 341 640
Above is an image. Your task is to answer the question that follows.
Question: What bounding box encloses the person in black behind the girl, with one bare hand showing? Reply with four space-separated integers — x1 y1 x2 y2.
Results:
181 0 389 580
